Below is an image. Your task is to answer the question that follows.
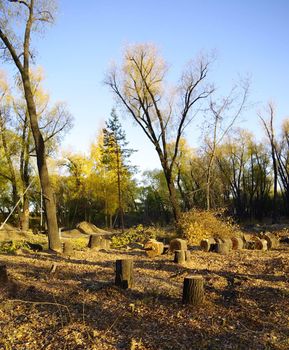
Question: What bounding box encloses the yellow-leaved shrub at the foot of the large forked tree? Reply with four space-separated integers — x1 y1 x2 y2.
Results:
179 209 240 244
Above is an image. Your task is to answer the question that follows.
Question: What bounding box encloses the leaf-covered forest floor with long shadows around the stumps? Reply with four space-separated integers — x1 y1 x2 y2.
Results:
0 231 289 350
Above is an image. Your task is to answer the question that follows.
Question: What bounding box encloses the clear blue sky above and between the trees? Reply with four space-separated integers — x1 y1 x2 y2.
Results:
34 0 289 169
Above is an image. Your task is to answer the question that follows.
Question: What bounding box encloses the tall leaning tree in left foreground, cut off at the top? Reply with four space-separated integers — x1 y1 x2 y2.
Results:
0 0 61 251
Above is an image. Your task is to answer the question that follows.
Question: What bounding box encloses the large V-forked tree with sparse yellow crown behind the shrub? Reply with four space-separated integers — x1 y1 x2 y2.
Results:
105 44 214 221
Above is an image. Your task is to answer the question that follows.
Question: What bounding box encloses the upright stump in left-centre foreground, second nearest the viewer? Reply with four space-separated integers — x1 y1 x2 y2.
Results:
115 259 134 289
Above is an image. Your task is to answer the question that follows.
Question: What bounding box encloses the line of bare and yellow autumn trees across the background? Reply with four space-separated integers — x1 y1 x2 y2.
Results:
0 0 289 251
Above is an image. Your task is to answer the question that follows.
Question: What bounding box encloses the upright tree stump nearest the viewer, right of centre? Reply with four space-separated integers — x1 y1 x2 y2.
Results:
182 275 204 305
